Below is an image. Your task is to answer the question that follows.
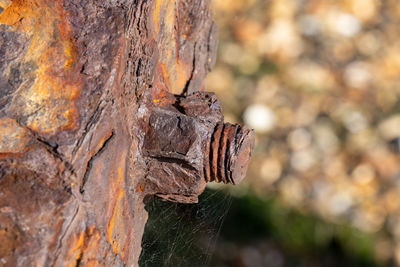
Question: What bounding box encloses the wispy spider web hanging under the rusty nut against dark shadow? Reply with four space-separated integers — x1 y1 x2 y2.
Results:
139 189 232 267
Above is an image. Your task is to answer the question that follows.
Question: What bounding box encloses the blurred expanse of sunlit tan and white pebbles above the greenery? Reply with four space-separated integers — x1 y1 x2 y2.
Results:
207 0 400 266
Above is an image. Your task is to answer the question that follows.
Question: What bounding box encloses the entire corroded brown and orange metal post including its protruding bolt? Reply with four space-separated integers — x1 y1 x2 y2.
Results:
0 0 253 266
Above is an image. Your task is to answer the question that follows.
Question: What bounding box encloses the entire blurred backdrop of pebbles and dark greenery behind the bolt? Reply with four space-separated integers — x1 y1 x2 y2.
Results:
142 0 400 267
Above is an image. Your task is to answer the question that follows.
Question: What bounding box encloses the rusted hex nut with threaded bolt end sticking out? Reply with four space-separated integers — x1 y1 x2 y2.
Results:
142 92 254 203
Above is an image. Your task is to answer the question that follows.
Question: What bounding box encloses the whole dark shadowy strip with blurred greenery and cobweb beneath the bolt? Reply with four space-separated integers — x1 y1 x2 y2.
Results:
140 189 379 267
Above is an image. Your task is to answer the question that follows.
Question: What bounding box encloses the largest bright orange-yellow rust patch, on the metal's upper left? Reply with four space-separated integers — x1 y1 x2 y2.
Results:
0 0 82 135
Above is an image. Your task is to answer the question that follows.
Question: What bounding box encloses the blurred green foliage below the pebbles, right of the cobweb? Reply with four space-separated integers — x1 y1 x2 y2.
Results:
221 194 378 266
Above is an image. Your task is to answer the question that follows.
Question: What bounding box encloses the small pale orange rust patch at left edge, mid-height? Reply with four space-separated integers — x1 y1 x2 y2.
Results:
0 118 30 154
